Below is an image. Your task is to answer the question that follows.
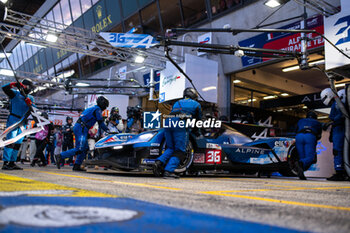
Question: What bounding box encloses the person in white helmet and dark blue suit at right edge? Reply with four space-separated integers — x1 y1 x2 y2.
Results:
327 89 347 181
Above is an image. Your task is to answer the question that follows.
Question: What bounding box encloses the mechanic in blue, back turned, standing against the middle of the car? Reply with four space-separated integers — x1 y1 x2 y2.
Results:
153 88 202 178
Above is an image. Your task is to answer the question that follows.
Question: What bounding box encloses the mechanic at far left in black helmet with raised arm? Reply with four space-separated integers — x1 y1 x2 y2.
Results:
2 79 34 170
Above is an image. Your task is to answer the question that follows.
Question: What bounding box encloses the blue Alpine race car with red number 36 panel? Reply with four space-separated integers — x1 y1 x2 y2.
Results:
85 125 298 176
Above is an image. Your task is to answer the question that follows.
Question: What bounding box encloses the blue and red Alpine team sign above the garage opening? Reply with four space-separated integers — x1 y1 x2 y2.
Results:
238 15 324 67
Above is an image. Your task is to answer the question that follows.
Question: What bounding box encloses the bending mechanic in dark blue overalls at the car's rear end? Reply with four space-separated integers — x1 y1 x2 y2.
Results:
295 111 322 180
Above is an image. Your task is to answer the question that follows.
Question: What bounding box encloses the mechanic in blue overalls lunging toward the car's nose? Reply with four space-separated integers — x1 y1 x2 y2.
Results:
55 96 109 171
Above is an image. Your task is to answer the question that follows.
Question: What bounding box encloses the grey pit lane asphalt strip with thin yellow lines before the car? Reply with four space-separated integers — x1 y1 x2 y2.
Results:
0 164 350 233
